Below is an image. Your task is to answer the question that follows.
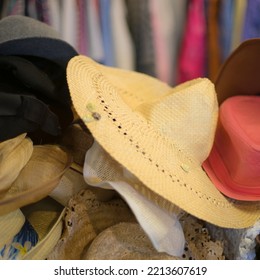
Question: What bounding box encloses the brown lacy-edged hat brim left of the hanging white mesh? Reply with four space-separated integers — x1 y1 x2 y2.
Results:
48 188 136 260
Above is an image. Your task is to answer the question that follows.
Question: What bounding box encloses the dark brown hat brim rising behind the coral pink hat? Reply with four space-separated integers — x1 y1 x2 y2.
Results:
214 38 260 104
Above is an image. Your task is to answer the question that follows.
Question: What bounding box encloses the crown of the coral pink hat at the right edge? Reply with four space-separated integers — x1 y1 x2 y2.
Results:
216 96 260 187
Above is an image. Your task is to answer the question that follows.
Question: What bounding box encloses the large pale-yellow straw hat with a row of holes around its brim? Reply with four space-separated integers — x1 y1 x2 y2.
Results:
67 56 260 228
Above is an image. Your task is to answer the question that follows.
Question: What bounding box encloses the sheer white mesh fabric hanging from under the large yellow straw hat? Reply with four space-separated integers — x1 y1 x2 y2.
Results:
84 141 185 256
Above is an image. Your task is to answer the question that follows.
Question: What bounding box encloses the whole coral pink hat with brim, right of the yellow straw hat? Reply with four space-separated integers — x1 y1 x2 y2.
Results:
203 95 260 201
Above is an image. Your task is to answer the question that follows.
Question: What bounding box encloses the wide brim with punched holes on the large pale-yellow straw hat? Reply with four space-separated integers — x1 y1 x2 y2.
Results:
67 56 260 228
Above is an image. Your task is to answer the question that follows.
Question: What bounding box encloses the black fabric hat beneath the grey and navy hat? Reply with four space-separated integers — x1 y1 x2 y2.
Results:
0 56 73 143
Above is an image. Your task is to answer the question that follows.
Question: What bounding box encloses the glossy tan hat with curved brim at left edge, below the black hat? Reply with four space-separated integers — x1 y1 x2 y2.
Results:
0 142 72 215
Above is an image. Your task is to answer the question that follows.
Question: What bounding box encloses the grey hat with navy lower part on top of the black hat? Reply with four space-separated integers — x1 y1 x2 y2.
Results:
0 15 78 69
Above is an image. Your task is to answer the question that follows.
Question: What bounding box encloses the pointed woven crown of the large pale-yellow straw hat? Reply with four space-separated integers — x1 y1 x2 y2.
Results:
136 78 218 165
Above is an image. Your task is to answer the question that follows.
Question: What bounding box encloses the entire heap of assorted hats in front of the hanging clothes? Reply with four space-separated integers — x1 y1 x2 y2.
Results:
0 16 260 259
